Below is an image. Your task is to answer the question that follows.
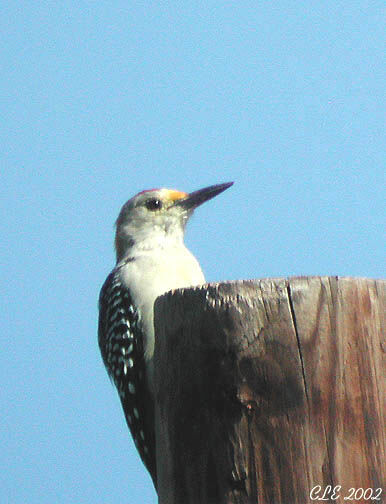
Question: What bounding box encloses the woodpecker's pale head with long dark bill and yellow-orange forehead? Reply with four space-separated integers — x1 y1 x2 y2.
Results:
115 182 233 262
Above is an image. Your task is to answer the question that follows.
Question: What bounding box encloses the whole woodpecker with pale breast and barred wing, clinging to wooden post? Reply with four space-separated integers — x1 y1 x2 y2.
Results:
98 182 233 488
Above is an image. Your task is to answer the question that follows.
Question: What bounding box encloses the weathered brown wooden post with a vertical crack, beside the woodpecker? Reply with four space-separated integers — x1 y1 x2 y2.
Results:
155 277 386 504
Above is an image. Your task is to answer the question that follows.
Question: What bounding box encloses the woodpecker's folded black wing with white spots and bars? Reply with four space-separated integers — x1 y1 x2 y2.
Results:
98 269 157 486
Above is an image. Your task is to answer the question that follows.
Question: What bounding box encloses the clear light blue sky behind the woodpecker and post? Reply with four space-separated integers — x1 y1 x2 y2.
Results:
0 0 386 504
